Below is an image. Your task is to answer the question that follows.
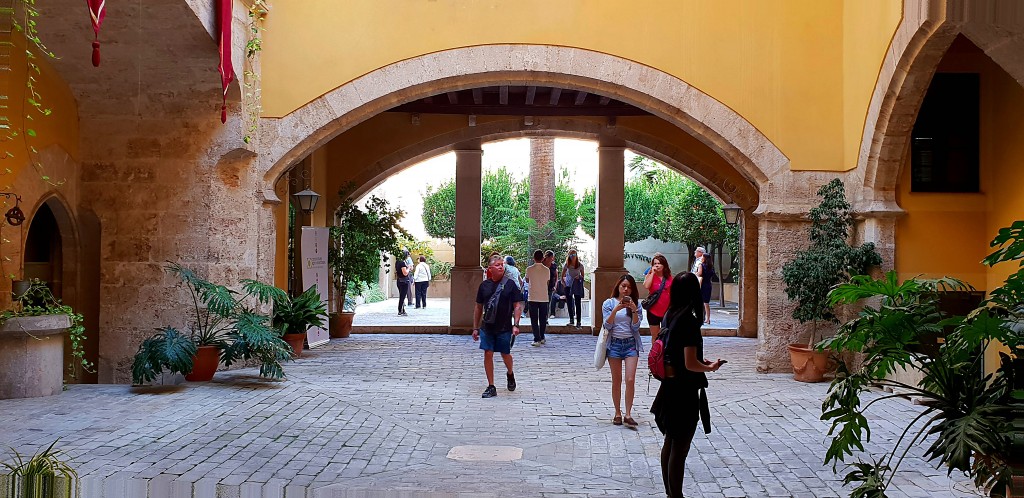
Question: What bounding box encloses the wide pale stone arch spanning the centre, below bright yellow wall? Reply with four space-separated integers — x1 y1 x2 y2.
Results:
259 44 788 197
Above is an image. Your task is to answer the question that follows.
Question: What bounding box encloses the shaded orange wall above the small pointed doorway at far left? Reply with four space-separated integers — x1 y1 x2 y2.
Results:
0 33 78 192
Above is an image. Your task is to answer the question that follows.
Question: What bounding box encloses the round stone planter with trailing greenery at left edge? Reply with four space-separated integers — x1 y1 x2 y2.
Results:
0 315 71 400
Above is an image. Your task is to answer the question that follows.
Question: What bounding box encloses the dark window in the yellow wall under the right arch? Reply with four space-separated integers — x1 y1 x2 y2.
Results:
910 73 980 193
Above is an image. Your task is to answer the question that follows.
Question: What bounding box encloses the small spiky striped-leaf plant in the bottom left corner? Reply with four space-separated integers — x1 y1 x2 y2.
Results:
0 440 78 498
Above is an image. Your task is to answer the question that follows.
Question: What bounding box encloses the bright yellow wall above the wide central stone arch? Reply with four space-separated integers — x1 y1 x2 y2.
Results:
261 0 901 170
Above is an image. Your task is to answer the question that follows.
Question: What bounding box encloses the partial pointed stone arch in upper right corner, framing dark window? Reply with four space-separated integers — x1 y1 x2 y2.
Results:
858 0 1024 202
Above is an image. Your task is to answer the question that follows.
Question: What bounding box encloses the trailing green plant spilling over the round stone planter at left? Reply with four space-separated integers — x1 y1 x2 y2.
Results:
0 279 95 382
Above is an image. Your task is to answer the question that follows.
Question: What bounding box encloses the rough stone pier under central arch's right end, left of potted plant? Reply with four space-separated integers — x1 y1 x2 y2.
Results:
756 215 813 373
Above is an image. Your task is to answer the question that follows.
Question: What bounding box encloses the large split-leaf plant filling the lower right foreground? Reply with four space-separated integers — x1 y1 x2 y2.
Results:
821 221 1024 498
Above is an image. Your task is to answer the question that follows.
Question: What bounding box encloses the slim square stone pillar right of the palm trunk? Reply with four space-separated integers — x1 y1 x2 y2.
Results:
590 142 627 331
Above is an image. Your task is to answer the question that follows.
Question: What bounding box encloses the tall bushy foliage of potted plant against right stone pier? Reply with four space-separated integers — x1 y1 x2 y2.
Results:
782 178 882 343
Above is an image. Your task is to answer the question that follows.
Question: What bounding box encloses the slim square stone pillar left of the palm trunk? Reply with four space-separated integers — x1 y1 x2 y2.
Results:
449 144 483 334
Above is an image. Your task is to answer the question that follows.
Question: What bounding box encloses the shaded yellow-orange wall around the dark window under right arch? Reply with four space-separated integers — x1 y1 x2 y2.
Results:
896 44 1024 291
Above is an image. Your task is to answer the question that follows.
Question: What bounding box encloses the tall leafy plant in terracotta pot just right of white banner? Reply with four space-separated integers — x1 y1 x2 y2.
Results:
328 185 411 337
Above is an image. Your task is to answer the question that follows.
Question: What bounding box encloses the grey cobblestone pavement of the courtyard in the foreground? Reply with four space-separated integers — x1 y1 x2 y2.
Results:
0 334 974 498
